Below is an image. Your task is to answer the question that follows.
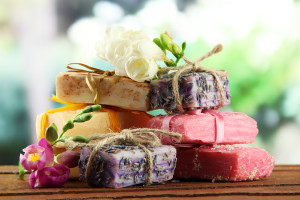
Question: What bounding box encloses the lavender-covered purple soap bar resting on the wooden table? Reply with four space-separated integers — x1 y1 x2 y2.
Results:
79 145 177 188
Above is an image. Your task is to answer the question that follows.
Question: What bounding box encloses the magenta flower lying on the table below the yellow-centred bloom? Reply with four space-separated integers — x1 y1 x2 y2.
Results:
29 164 70 188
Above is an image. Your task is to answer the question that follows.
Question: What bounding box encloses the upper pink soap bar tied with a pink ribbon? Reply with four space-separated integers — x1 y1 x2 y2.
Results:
148 111 258 144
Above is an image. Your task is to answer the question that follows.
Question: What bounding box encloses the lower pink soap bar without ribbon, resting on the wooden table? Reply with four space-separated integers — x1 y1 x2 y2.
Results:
174 145 275 181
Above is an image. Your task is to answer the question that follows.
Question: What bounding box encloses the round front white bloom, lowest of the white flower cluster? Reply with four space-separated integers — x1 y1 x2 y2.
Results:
125 56 158 82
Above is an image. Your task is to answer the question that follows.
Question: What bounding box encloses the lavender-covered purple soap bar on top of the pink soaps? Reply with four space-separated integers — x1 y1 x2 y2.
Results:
150 70 231 111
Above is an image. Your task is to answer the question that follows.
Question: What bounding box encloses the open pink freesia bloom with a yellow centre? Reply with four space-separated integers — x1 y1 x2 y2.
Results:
20 138 54 171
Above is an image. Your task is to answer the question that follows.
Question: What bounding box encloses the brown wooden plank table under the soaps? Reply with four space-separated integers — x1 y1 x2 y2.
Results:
0 165 300 200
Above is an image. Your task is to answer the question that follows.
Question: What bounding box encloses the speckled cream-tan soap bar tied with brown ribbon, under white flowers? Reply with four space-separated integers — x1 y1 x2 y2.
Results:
56 72 150 111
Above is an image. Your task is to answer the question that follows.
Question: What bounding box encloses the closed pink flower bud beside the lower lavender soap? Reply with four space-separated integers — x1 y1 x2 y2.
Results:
55 151 80 168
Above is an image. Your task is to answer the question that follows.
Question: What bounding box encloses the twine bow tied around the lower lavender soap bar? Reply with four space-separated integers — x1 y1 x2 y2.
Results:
65 128 182 185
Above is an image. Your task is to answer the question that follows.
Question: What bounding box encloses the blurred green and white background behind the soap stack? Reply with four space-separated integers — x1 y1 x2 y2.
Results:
0 0 300 164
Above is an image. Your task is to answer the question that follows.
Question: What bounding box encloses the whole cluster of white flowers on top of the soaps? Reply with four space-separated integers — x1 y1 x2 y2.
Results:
96 26 168 82
